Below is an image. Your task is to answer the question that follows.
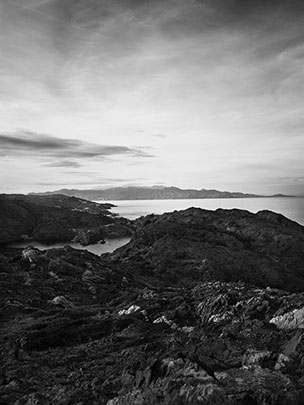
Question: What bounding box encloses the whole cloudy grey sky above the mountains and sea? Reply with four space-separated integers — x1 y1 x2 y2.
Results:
0 0 304 195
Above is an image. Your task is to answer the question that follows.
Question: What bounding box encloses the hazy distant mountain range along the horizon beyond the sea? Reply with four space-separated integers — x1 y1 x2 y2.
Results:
31 186 288 201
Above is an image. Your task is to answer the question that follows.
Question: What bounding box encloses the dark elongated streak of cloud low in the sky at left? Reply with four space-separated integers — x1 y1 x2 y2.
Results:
0 130 153 160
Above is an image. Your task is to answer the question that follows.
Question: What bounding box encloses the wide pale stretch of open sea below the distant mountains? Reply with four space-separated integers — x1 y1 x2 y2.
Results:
97 197 304 225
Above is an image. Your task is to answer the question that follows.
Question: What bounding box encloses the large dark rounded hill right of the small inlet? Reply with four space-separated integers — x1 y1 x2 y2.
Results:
112 208 304 291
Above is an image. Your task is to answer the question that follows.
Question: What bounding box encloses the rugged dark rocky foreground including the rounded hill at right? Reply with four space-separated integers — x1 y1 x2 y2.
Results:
0 208 304 405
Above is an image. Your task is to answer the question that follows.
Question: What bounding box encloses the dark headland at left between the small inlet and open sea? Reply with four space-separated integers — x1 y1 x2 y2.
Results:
0 194 133 246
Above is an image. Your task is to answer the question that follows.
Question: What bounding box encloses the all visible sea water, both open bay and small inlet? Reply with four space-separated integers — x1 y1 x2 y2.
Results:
11 197 304 255
